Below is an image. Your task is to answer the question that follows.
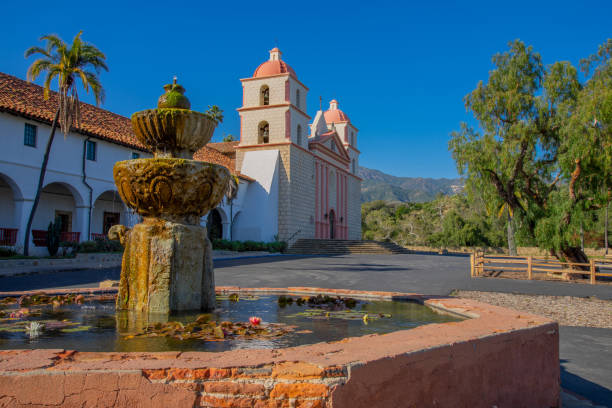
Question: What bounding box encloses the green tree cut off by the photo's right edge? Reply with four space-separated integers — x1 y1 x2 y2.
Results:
536 39 612 262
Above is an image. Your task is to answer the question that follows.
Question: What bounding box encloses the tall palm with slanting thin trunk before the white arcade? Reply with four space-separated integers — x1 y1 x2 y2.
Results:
23 31 108 255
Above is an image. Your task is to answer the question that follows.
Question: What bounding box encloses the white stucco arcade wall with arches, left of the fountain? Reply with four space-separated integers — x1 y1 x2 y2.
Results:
0 113 151 255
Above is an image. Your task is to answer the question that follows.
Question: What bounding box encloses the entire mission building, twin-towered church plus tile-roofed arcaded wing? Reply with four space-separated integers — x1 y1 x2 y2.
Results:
0 48 361 255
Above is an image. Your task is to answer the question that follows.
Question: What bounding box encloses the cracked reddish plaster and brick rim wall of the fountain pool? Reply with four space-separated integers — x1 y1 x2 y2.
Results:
0 287 560 408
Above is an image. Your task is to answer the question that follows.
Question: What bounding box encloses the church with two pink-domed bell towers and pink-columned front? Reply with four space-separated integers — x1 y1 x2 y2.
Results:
235 48 361 244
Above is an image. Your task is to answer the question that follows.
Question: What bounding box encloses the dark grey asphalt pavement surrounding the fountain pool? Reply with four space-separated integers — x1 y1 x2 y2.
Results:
0 254 612 406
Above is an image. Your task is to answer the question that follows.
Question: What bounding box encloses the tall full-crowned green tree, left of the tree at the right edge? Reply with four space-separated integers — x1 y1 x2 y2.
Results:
449 40 585 260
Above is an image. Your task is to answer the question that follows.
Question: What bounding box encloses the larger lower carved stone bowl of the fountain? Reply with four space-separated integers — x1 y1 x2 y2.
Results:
113 158 230 223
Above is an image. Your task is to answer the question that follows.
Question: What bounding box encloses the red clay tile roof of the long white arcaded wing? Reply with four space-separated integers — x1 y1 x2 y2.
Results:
0 72 251 180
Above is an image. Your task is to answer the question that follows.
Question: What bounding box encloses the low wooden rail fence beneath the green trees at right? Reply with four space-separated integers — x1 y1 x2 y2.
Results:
470 252 612 284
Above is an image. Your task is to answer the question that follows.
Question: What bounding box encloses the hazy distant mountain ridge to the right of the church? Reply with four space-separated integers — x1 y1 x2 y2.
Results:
357 167 463 203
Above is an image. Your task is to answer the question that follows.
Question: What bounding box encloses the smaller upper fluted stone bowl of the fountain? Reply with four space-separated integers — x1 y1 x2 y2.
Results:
132 108 217 159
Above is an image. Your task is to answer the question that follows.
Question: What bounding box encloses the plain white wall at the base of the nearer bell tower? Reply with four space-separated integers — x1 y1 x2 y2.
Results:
233 150 279 242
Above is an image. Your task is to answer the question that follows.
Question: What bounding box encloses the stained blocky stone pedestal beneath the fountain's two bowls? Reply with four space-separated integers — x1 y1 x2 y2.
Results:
117 218 215 313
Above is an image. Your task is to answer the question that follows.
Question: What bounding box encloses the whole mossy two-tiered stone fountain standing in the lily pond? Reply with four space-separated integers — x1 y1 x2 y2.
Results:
109 78 230 313
